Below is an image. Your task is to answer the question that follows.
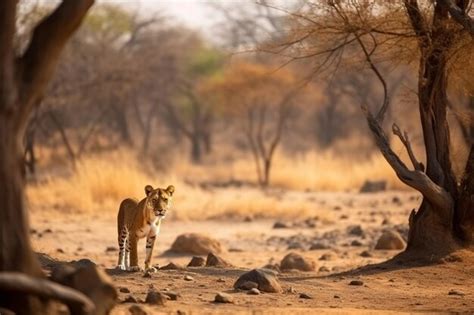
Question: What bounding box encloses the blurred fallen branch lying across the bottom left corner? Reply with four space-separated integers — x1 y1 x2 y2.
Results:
0 272 95 315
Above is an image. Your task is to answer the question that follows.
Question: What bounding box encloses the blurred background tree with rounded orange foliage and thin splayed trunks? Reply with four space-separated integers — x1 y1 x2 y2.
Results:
202 62 301 187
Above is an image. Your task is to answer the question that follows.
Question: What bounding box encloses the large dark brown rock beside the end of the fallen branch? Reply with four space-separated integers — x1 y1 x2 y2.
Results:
51 259 118 314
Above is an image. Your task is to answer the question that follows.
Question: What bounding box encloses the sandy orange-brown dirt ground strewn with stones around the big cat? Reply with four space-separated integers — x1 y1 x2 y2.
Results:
30 192 474 314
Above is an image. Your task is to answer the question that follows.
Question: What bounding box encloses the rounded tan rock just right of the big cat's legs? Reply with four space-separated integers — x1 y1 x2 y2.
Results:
170 233 222 255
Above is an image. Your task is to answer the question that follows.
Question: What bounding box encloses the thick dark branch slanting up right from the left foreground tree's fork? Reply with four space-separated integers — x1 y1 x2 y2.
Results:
17 0 94 124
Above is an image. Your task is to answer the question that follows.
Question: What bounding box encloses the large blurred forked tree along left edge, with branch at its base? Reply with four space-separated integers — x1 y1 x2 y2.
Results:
0 0 93 314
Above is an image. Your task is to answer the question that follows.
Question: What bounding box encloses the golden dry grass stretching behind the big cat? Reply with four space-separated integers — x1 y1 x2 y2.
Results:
27 152 403 220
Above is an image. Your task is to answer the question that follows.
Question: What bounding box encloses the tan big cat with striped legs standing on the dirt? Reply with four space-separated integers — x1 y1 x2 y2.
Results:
117 185 174 270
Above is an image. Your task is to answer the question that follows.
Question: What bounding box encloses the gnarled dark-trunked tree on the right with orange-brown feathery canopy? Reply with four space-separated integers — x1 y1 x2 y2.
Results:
271 0 474 254
